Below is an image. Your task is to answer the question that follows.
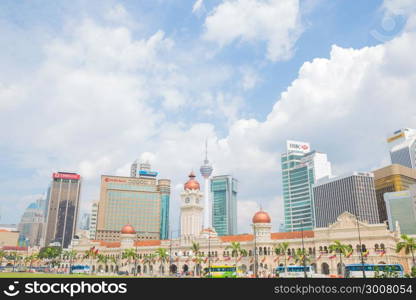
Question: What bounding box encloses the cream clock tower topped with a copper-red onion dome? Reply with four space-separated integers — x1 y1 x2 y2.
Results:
181 172 204 238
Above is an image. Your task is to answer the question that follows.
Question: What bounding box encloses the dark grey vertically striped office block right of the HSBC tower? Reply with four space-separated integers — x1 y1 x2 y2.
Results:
313 172 379 228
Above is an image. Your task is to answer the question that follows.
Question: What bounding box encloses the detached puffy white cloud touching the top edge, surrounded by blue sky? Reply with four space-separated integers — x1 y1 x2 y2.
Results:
204 0 302 61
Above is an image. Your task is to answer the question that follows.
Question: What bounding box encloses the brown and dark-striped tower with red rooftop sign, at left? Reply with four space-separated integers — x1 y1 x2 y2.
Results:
45 172 81 248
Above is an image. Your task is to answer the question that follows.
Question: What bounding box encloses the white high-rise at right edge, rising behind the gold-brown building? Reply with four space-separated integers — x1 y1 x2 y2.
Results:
387 128 416 169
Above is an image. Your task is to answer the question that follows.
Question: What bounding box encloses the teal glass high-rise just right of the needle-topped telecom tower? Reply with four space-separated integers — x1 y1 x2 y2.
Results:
211 175 238 235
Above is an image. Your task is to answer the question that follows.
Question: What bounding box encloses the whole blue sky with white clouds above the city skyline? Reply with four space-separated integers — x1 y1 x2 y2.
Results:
0 0 416 233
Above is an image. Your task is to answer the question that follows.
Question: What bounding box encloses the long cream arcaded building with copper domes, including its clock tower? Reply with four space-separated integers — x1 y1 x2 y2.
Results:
67 173 412 276
